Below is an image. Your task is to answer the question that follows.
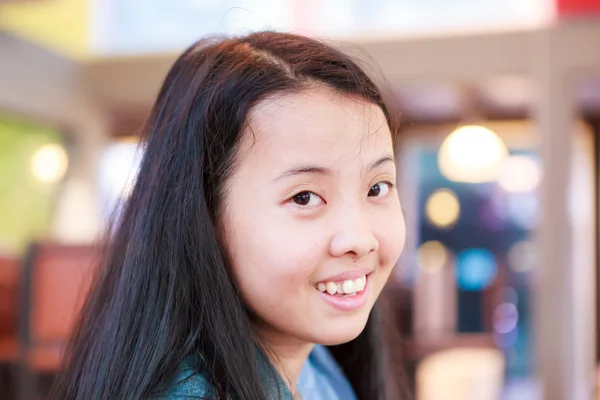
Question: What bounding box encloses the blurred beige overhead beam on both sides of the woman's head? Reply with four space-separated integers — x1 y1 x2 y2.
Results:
0 18 600 135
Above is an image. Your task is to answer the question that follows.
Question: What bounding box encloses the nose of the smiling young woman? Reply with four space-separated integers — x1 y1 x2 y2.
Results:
329 207 379 261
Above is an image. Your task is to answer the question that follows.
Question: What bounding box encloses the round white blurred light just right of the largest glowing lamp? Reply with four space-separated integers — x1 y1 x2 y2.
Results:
498 155 542 193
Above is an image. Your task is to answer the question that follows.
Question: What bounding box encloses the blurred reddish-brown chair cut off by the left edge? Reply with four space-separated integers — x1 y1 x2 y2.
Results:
0 255 20 397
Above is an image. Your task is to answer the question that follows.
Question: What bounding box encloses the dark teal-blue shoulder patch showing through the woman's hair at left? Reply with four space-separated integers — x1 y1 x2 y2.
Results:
151 361 214 400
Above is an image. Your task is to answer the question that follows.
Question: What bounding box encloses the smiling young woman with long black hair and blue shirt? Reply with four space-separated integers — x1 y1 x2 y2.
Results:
51 32 405 400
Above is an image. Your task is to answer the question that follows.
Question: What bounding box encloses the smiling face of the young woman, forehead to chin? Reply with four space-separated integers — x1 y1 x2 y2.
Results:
221 88 406 345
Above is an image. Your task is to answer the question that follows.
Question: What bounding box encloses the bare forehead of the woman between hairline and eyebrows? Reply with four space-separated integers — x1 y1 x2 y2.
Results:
244 88 392 162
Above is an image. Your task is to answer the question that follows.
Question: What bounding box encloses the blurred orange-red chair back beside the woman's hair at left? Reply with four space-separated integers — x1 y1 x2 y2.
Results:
19 243 97 400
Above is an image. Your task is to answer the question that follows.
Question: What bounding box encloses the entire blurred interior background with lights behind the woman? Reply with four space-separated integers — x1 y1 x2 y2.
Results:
0 0 600 400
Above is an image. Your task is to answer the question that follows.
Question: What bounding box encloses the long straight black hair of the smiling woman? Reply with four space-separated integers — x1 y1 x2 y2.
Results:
51 32 408 400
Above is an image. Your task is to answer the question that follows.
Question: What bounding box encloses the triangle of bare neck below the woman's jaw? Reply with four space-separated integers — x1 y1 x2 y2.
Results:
260 330 314 398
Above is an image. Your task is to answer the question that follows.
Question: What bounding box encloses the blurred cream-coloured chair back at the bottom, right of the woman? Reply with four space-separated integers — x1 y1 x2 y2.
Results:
416 348 505 400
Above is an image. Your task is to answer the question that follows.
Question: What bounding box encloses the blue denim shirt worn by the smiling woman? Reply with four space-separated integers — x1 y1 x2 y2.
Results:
155 345 356 400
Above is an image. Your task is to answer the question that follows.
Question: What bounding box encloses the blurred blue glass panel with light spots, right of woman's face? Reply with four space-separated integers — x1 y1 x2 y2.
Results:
403 121 542 399
